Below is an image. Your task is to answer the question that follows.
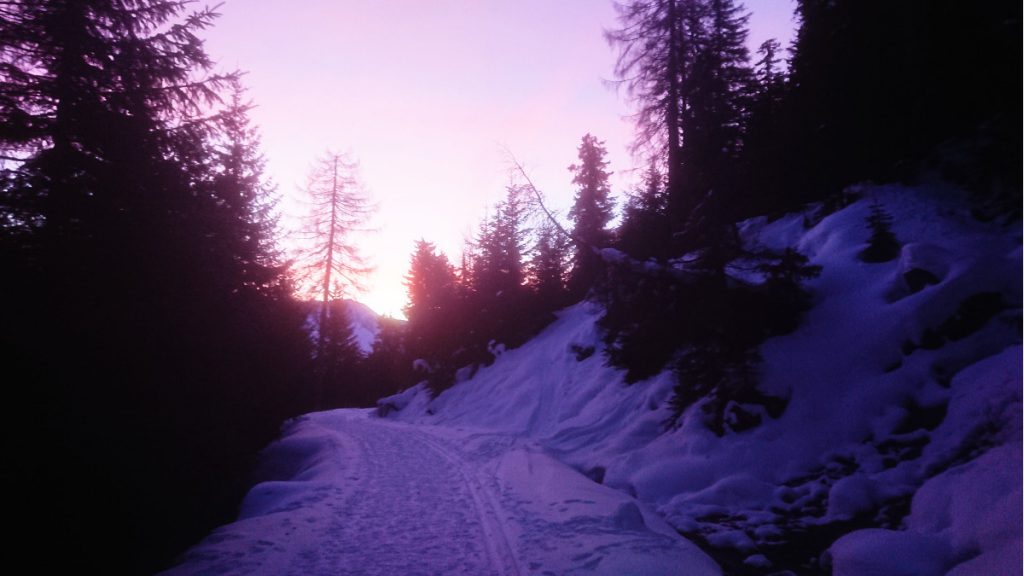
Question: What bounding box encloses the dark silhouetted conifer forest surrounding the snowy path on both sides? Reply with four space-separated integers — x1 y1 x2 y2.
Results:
0 0 1022 573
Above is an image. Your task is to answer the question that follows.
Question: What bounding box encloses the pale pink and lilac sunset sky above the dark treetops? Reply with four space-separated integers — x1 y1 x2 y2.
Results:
206 0 794 316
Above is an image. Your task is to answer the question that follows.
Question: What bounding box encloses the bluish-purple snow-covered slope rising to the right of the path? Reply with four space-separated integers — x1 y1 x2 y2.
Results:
384 186 1022 575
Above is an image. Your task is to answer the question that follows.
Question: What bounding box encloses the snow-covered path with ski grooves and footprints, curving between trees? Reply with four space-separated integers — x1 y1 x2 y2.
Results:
161 410 719 576
